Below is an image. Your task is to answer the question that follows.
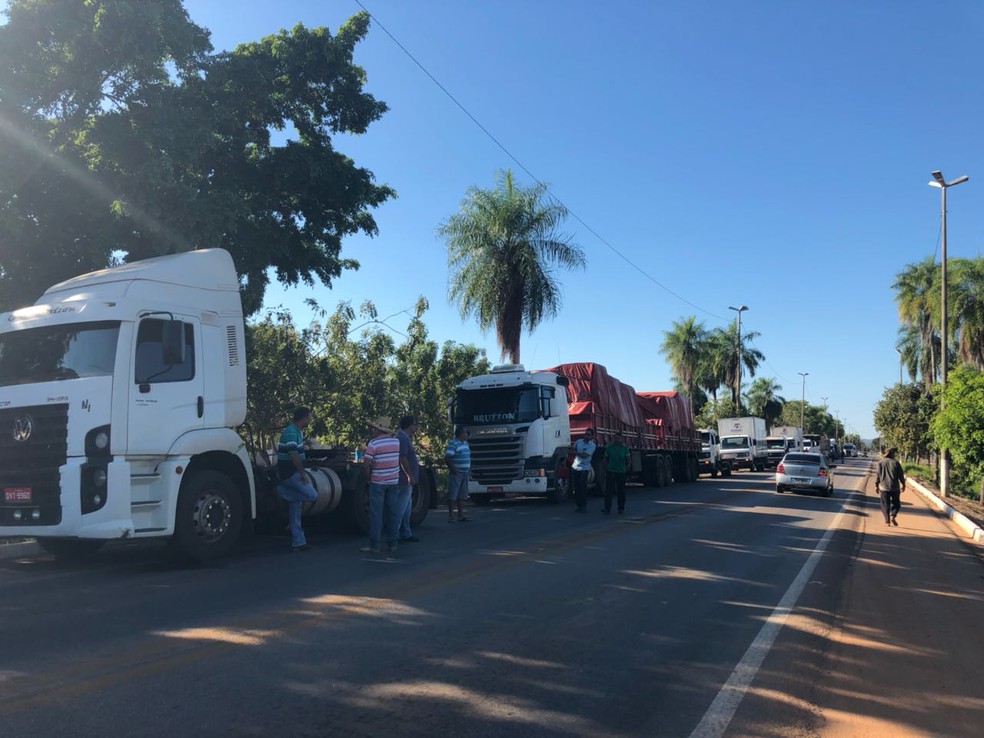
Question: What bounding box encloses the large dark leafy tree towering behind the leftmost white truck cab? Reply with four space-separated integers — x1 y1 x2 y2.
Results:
0 0 393 312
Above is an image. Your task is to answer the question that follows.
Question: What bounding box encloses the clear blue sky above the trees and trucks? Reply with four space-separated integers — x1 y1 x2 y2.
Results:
185 0 984 437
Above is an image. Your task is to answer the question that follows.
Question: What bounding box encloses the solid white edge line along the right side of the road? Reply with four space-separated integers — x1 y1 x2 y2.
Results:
690 490 855 738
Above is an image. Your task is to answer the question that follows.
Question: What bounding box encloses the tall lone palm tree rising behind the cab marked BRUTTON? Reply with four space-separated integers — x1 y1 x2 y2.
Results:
438 170 585 364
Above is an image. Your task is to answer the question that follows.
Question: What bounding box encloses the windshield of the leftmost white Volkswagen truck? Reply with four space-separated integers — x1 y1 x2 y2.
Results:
0 321 120 386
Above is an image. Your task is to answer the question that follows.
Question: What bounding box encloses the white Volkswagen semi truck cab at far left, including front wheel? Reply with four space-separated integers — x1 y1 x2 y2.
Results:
0 249 255 557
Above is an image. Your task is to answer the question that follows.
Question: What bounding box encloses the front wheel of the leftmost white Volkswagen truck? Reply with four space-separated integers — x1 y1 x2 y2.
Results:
174 469 244 561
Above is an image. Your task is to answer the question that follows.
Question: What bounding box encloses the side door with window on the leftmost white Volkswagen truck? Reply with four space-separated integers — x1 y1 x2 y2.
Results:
127 313 205 456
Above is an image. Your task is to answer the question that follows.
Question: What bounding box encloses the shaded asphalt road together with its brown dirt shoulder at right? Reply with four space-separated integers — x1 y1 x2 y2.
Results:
0 460 984 738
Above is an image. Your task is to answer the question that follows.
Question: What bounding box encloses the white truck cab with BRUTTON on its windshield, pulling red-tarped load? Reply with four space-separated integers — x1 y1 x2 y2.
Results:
452 364 571 502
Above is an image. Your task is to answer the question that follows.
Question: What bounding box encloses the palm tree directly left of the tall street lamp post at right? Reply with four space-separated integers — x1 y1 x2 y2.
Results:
892 256 940 390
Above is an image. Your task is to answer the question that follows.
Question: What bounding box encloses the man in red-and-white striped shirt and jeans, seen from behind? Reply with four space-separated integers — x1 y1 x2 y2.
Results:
362 423 403 553
